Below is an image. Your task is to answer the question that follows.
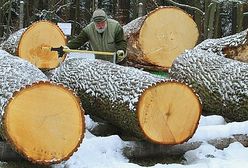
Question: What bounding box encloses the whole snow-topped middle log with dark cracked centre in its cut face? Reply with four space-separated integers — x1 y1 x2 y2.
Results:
52 58 201 144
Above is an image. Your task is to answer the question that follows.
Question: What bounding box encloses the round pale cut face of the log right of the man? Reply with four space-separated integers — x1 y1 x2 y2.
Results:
139 7 199 67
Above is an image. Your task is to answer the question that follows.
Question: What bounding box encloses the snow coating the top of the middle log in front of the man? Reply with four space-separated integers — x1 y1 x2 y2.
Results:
51 56 164 111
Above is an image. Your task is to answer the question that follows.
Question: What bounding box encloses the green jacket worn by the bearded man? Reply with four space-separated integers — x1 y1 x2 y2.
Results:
67 19 127 62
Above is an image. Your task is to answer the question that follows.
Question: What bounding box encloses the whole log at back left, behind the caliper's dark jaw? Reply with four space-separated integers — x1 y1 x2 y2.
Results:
2 20 67 69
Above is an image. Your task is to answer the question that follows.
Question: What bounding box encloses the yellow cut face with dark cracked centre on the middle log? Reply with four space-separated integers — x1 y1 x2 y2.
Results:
138 82 201 144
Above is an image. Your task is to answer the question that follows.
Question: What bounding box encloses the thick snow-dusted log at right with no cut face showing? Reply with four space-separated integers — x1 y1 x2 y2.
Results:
169 48 248 121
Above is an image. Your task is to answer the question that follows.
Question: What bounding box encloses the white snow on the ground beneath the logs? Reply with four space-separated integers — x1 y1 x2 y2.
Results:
53 116 248 168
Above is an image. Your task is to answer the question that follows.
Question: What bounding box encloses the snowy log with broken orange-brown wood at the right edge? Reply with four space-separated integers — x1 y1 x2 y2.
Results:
196 29 248 63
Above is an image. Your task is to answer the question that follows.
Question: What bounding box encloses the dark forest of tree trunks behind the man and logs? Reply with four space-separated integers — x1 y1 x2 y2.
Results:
0 0 248 41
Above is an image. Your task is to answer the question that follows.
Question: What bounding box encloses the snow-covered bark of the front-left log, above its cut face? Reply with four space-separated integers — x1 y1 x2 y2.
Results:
0 50 48 113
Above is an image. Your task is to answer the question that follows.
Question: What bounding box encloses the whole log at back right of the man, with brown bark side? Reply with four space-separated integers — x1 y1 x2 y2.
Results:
123 7 199 70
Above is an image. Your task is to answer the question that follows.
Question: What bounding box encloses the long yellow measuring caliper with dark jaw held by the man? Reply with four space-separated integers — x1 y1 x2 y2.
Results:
42 46 121 64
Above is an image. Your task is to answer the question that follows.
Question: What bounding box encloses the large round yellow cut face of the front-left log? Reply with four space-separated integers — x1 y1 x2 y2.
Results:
3 83 84 162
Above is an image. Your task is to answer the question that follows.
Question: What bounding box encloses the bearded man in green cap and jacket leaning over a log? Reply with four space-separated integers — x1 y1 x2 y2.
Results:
67 9 127 63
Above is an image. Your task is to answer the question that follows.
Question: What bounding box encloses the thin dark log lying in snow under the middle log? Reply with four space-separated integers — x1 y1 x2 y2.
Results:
122 135 248 159
